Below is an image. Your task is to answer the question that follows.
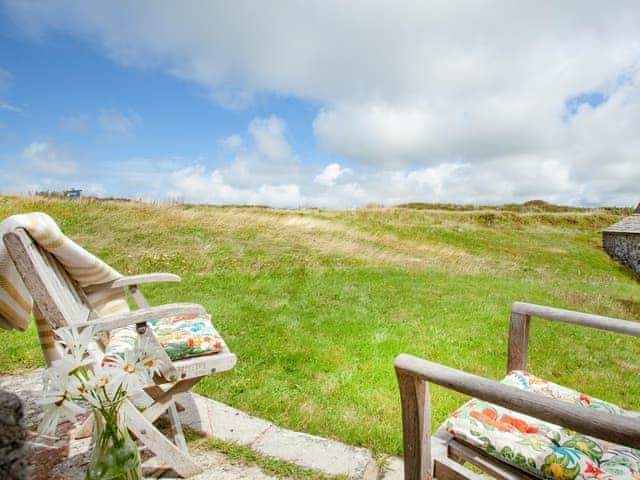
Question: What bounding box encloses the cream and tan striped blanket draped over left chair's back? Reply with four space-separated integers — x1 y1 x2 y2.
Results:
0 212 129 330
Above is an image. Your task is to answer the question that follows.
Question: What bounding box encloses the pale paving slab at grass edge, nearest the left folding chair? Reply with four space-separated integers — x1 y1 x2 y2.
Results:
178 393 273 445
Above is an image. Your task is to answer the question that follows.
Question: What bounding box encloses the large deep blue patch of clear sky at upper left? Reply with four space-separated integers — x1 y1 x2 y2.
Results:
0 17 331 200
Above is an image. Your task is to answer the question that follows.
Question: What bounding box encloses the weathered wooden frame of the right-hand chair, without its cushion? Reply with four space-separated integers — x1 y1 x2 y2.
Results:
395 302 640 480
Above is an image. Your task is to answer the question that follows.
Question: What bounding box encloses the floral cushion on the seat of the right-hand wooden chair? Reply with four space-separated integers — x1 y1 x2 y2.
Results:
444 371 640 480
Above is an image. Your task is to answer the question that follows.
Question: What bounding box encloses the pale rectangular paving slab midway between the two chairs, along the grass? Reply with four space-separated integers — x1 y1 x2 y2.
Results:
253 427 372 479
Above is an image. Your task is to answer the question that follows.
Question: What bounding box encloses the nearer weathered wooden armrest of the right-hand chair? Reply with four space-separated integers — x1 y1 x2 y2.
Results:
395 354 640 448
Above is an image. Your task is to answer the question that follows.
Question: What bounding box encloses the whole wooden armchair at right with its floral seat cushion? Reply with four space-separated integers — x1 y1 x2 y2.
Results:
395 302 640 480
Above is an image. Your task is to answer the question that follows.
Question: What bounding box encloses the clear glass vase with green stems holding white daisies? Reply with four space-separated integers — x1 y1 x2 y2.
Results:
85 402 142 480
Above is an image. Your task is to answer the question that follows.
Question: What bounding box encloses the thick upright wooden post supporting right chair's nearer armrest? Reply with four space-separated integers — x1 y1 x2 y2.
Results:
396 370 433 480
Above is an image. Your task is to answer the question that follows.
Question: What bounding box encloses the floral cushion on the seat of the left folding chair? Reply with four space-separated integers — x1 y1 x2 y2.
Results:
103 314 224 364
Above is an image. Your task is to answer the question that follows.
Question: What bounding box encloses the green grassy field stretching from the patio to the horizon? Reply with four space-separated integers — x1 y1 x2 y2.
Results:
0 197 640 454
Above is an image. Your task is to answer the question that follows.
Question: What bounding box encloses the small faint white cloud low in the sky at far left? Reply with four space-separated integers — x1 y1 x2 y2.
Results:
22 142 79 178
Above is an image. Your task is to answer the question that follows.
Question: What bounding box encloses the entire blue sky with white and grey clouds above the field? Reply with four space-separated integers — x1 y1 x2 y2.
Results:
0 0 640 208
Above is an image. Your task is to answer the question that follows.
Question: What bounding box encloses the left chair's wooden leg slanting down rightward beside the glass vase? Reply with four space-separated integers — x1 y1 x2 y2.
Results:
124 400 202 478
